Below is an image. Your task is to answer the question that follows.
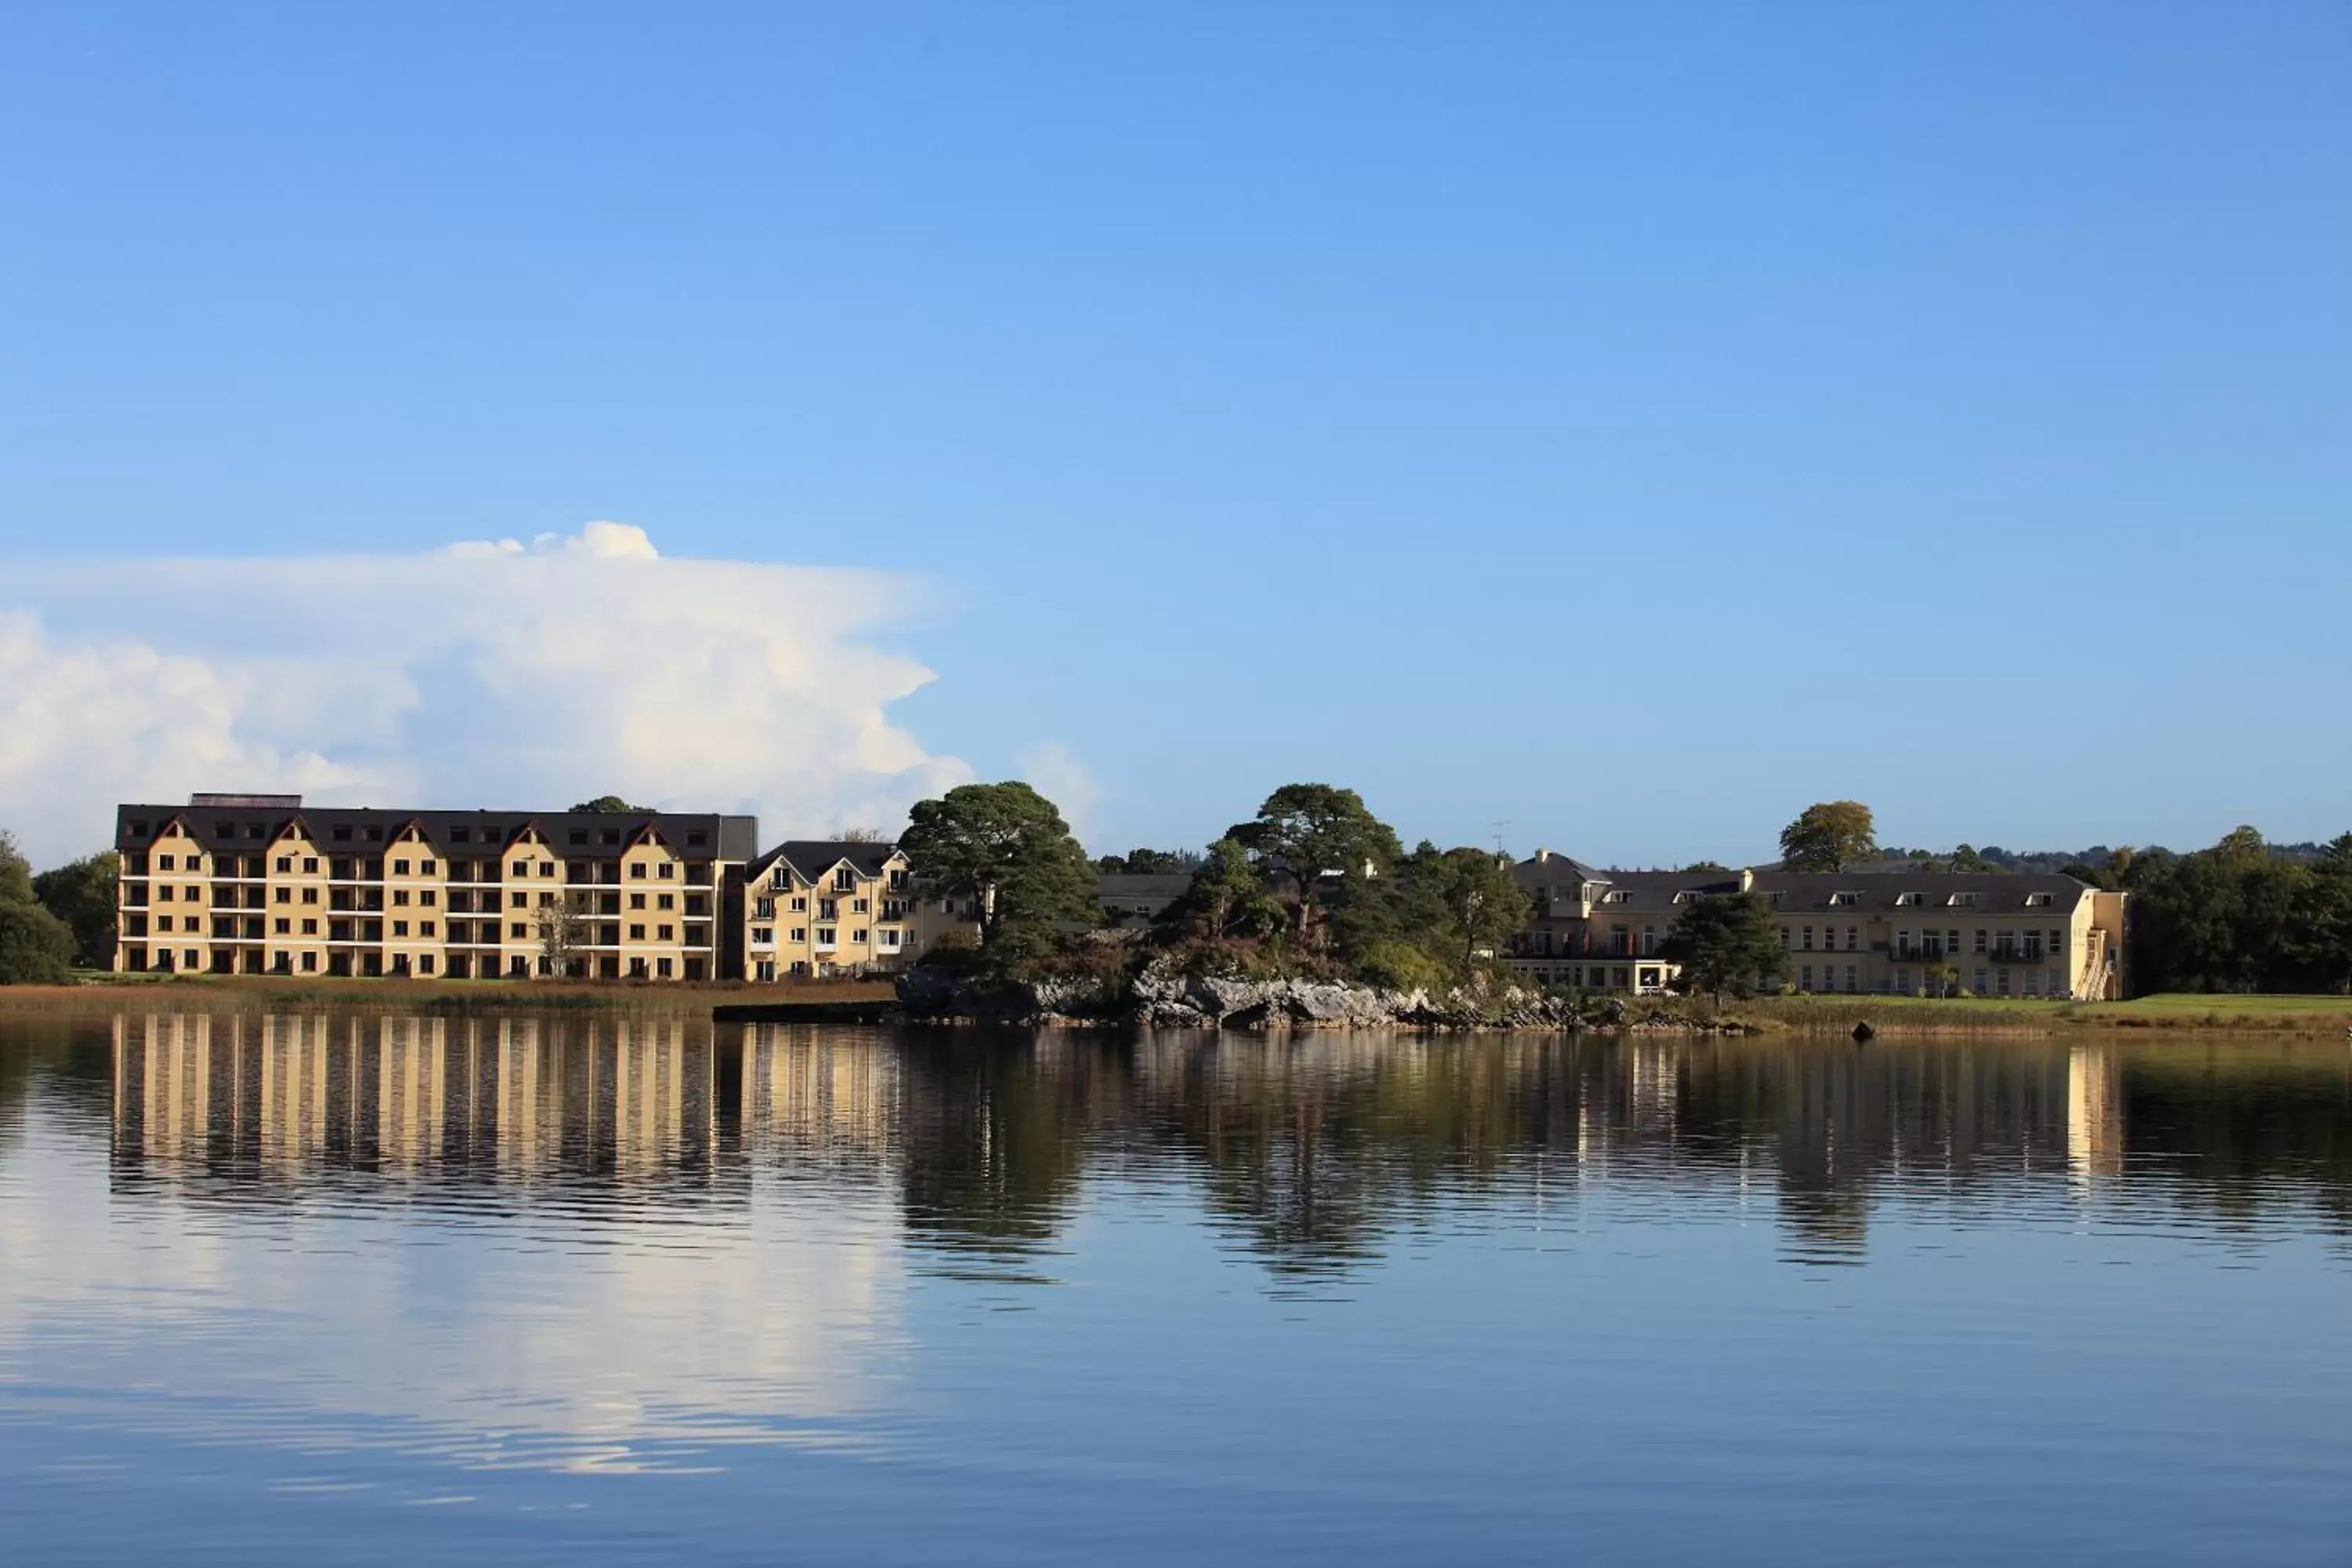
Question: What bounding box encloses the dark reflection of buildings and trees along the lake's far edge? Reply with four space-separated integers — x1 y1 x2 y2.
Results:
113 1013 2352 1274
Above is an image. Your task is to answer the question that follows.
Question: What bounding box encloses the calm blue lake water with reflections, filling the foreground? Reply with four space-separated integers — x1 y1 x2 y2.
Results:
0 1013 2352 1563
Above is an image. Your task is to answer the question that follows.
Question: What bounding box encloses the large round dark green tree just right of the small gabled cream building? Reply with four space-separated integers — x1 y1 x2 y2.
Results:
898 781 1098 966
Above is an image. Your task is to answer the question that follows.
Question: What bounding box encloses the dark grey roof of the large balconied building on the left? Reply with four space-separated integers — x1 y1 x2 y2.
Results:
115 797 760 860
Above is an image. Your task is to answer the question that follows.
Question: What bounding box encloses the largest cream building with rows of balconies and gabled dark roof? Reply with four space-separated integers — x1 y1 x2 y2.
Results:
115 794 760 980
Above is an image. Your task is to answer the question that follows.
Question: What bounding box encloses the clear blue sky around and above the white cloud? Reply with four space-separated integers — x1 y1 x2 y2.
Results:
0 2 2352 862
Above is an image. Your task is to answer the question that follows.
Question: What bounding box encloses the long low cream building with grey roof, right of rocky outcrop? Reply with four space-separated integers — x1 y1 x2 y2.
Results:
1510 848 2124 1001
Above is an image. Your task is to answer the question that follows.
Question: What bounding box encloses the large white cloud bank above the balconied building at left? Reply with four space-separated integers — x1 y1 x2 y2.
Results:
0 522 971 862
